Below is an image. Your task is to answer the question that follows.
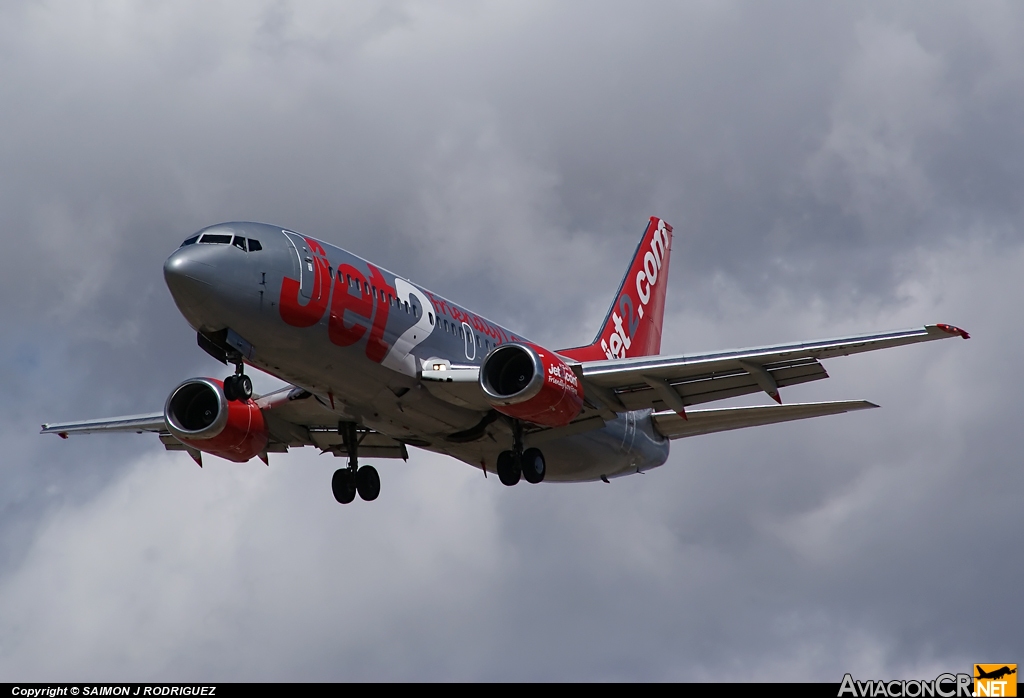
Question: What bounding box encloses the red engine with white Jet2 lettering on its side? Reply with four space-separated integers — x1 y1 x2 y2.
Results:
480 344 583 427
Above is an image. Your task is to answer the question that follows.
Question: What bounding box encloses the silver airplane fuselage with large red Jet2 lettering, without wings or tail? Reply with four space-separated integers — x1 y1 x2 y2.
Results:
164 223 669 481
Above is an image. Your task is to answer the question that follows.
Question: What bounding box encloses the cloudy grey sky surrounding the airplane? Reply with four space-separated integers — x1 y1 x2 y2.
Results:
0 0 1024 683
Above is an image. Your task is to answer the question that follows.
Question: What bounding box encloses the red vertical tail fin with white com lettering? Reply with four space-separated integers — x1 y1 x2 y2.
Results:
558 216 672 361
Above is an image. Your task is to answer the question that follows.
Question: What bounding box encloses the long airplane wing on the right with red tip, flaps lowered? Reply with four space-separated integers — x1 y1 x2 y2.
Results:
572 324 970 415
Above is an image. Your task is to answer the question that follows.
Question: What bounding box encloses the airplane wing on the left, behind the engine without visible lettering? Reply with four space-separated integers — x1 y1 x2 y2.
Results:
40 387 409 461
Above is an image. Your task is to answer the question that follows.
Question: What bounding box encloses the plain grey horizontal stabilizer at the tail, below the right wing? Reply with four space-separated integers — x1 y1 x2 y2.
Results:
651 400 879 439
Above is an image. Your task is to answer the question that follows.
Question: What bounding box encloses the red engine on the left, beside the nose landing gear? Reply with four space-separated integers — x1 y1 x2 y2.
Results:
164 378 269 463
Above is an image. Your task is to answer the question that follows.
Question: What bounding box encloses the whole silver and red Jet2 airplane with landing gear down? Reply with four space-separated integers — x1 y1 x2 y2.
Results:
41 217 970 504
